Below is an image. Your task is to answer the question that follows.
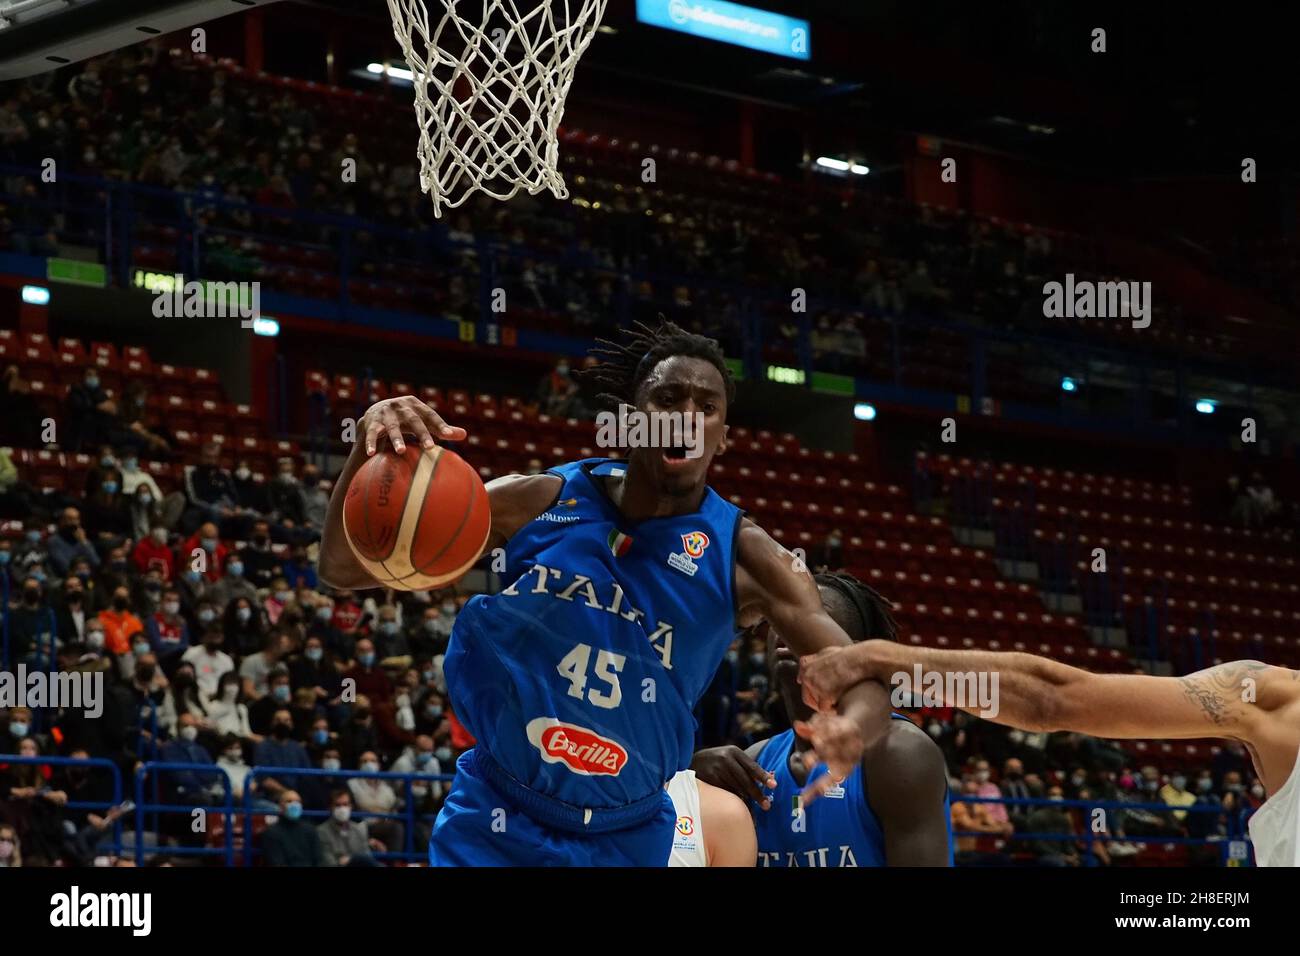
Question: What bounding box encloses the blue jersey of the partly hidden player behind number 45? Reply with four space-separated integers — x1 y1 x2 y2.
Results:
750 714 953 866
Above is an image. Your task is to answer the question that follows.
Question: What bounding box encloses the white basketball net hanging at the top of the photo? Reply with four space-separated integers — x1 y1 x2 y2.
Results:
387 0 607 216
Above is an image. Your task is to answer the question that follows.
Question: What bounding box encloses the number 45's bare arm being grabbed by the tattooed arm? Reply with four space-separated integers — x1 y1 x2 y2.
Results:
736 520 889 779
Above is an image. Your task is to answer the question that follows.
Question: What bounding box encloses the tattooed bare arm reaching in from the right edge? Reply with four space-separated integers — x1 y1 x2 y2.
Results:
800 641 1300 793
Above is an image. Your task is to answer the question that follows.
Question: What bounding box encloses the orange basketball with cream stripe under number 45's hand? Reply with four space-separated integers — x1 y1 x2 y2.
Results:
343 444 491 591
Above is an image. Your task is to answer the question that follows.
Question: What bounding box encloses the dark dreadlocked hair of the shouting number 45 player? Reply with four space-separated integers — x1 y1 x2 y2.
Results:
579 315 736 408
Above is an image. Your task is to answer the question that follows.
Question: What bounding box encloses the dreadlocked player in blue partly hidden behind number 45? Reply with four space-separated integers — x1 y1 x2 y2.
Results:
692 572 953 866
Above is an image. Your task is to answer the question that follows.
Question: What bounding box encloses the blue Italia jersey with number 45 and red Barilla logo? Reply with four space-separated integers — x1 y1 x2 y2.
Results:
443 459 742 809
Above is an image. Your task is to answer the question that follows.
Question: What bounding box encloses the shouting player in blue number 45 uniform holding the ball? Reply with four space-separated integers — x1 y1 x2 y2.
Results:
320 323 889 866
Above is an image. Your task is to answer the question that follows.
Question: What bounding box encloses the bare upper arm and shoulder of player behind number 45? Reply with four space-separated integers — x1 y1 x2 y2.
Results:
862 721 949 866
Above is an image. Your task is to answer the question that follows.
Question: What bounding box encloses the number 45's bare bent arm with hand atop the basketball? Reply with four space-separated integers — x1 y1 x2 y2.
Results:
319 395 563 589
